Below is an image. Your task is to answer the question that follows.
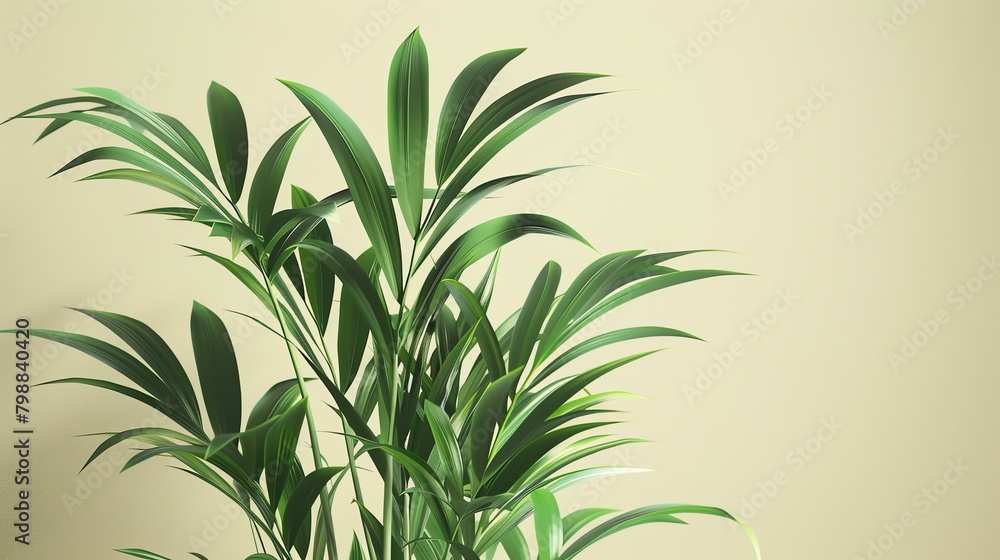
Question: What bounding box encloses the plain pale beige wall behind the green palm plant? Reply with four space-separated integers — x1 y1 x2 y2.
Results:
0 0 1000 560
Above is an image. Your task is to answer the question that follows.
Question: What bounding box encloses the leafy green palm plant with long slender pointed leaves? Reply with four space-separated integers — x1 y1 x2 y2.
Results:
5 31 759 560
